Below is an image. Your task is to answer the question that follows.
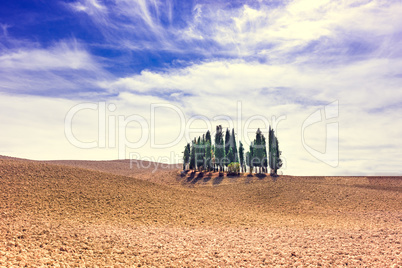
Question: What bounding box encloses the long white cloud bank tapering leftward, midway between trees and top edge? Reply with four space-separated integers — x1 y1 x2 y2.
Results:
101 55 402 111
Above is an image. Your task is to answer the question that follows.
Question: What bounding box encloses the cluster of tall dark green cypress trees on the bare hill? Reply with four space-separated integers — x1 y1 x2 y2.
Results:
183 125 282 175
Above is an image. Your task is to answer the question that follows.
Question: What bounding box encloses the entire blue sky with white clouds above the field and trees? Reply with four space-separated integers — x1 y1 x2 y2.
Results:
0 0 402 176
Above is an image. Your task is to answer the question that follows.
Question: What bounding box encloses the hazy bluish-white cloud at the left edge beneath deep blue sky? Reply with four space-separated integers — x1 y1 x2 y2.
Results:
0 40 112 96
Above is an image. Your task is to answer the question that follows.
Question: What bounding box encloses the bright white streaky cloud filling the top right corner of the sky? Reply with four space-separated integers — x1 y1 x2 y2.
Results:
176 1 402 62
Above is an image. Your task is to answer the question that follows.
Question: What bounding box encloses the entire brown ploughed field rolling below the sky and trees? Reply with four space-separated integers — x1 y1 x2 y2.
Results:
0 157 402 267
